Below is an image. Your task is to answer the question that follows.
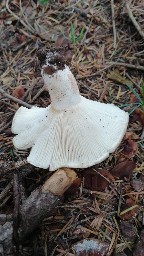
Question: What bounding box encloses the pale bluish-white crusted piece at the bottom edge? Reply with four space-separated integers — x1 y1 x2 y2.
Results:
72 239 109 256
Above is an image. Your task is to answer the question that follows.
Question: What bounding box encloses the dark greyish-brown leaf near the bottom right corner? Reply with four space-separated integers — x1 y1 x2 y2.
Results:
120 221 138 242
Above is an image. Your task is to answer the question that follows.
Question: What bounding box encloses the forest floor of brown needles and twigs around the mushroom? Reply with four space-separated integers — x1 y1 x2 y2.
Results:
0 0 144 256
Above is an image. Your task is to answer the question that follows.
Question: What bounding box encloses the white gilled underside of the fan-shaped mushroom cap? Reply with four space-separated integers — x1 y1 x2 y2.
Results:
12 97 129 171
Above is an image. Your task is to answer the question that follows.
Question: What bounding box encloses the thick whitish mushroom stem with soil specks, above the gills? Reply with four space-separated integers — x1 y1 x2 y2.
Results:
42 65 81 111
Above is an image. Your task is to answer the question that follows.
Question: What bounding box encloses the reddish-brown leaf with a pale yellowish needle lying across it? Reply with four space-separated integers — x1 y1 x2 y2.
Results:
120 198 138 220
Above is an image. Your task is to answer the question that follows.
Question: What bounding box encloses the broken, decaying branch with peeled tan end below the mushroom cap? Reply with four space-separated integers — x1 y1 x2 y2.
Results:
0 168 77 255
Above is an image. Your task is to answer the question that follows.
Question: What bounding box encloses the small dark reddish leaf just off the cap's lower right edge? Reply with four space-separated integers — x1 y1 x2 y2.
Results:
121 140 138 158
